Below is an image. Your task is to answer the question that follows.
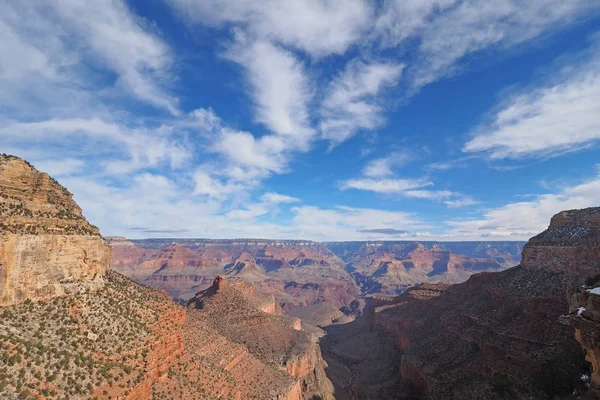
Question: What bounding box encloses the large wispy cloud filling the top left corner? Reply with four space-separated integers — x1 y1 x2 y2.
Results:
0 0 178 114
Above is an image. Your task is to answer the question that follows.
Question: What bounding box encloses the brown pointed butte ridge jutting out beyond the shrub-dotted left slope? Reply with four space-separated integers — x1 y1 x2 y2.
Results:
188 275 333 399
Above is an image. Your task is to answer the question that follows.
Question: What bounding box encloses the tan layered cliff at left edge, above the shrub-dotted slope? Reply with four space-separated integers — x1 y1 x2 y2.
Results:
0 155 111 305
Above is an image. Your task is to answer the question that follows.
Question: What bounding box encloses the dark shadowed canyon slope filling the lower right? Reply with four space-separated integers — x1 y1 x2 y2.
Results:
323 208 600 400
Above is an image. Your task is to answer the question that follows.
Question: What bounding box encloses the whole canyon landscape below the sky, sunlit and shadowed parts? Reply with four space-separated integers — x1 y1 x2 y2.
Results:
0 156 600 400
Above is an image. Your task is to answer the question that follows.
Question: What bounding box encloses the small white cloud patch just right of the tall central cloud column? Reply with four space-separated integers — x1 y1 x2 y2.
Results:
320 60 404 145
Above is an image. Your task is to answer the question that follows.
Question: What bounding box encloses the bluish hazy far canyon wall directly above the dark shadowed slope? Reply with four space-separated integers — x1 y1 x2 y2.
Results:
326 242 522 295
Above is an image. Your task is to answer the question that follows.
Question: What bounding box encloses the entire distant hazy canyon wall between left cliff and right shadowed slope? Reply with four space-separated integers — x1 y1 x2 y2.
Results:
108 237 522 332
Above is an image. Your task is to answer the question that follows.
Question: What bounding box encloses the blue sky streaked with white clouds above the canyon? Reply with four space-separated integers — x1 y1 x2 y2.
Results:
0 0 600 241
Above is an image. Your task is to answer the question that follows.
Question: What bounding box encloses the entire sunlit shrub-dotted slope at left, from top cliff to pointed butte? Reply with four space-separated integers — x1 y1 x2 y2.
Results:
0 156 332 400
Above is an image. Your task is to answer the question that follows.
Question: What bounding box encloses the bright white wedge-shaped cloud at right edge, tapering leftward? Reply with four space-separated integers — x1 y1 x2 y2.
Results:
463 46 600 159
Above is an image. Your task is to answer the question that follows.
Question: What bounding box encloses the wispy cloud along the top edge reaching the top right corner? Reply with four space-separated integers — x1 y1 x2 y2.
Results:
376 0 600 89
